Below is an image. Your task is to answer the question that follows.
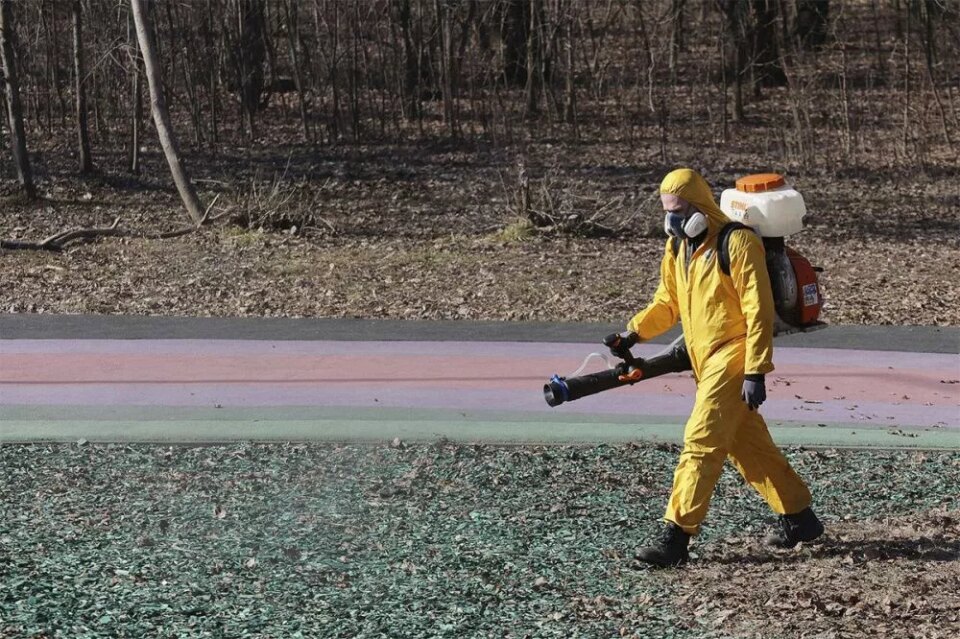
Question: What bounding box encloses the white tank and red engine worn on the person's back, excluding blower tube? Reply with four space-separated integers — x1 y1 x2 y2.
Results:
720 173 823 333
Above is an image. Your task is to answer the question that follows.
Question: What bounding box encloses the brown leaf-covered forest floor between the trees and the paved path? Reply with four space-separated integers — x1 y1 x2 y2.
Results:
0 142 960 326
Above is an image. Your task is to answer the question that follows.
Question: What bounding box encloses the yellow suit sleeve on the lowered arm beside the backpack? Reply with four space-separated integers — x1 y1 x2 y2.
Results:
728 231 776 375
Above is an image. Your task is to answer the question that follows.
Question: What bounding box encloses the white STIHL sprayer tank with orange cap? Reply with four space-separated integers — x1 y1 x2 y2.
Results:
720 173 807 237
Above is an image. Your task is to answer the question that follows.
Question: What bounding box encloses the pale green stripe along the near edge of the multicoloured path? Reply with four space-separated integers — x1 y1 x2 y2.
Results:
0 406 960 449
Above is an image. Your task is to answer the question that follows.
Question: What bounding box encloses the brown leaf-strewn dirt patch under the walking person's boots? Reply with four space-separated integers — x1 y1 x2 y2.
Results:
674 511 960 639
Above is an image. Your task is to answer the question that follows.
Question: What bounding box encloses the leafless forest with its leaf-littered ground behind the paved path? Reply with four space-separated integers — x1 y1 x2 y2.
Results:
0 0 960 325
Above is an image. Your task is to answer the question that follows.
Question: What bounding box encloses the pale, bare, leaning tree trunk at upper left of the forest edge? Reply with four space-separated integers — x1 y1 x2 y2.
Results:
130 0 204 224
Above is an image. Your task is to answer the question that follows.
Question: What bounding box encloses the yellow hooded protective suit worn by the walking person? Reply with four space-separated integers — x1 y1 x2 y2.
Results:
627 169 810 534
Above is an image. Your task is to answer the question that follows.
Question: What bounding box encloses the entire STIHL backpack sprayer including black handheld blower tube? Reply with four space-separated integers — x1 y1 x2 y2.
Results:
543 173 826 406
